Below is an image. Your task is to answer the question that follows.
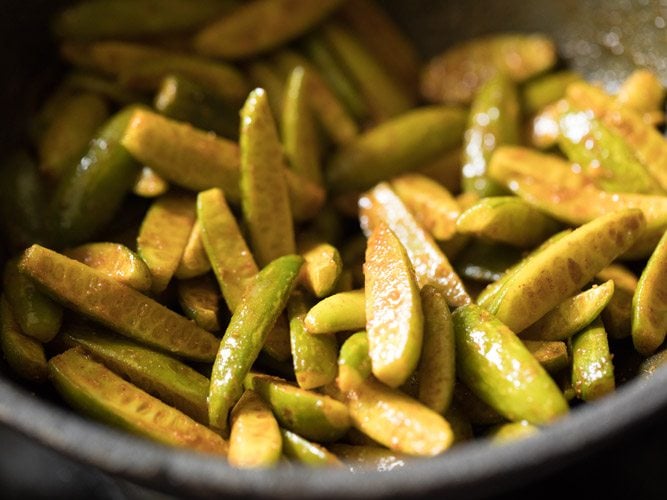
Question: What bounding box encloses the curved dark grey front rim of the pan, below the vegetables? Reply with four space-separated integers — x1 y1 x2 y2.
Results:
0 369 667 499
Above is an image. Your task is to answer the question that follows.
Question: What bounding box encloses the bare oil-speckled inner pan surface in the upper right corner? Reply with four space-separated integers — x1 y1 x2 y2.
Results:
383 0 667 89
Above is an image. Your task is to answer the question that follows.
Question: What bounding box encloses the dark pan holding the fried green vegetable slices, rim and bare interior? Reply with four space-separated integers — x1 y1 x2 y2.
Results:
0 0 667 498
